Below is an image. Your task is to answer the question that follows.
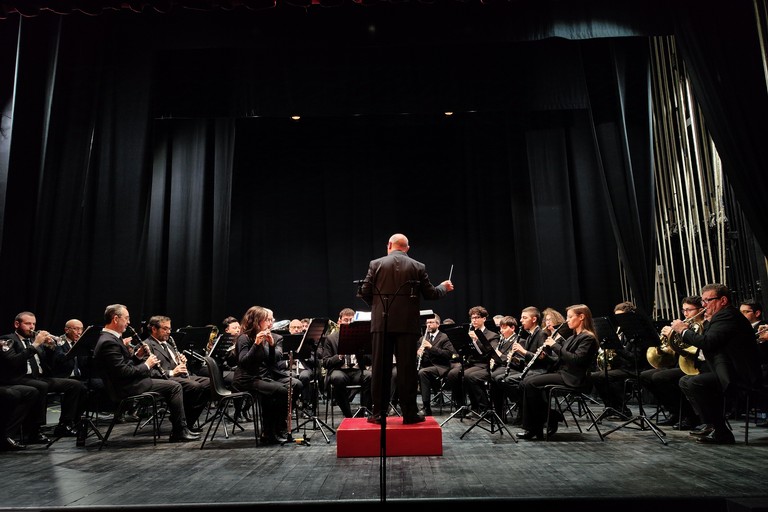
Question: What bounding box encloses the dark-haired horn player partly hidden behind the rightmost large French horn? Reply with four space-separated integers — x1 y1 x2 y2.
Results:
640 295 711 435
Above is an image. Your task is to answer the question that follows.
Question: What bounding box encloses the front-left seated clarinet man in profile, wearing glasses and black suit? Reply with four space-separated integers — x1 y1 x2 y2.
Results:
93 304 200 443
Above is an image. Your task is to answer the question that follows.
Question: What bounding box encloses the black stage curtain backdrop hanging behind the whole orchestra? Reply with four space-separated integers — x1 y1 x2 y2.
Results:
0 5 680 330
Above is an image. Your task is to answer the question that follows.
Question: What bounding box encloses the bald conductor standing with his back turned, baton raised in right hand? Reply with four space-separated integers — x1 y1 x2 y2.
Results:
358 233 453 425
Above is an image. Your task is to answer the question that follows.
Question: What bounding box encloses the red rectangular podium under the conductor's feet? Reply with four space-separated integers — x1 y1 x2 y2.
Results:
336 416 443 457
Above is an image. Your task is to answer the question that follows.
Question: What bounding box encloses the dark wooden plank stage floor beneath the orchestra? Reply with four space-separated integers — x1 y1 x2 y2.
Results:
0 400 768 512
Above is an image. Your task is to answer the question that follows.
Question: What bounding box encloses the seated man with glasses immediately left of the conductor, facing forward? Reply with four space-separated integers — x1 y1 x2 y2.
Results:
323 308 371 418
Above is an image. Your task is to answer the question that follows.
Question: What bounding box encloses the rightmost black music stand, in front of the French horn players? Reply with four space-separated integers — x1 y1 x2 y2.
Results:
603 313 667 445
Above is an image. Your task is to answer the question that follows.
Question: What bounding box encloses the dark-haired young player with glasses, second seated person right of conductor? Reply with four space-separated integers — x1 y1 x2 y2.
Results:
445 306 499 414
